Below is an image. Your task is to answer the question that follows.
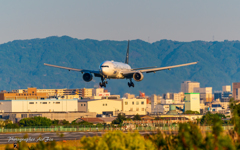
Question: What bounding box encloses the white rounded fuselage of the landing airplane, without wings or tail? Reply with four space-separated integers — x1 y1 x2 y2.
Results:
99 61 131 79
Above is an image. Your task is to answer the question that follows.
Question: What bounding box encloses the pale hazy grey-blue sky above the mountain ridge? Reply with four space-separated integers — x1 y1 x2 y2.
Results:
0 0 240 44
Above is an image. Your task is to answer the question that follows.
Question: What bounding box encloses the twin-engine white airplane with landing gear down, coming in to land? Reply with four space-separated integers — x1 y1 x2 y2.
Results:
44 40 198 87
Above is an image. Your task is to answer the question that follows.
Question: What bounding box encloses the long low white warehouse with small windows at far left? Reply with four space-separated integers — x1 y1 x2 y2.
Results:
0 99 78 113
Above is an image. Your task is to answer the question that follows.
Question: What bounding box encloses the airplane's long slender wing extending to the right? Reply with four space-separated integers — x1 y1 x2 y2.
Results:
121 62 198 76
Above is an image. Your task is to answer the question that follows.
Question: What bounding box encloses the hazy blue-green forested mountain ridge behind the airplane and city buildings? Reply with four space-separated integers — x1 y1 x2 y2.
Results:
0 36 240 95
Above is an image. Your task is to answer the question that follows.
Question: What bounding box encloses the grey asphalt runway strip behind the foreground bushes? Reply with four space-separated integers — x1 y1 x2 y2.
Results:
0 132 158 144
